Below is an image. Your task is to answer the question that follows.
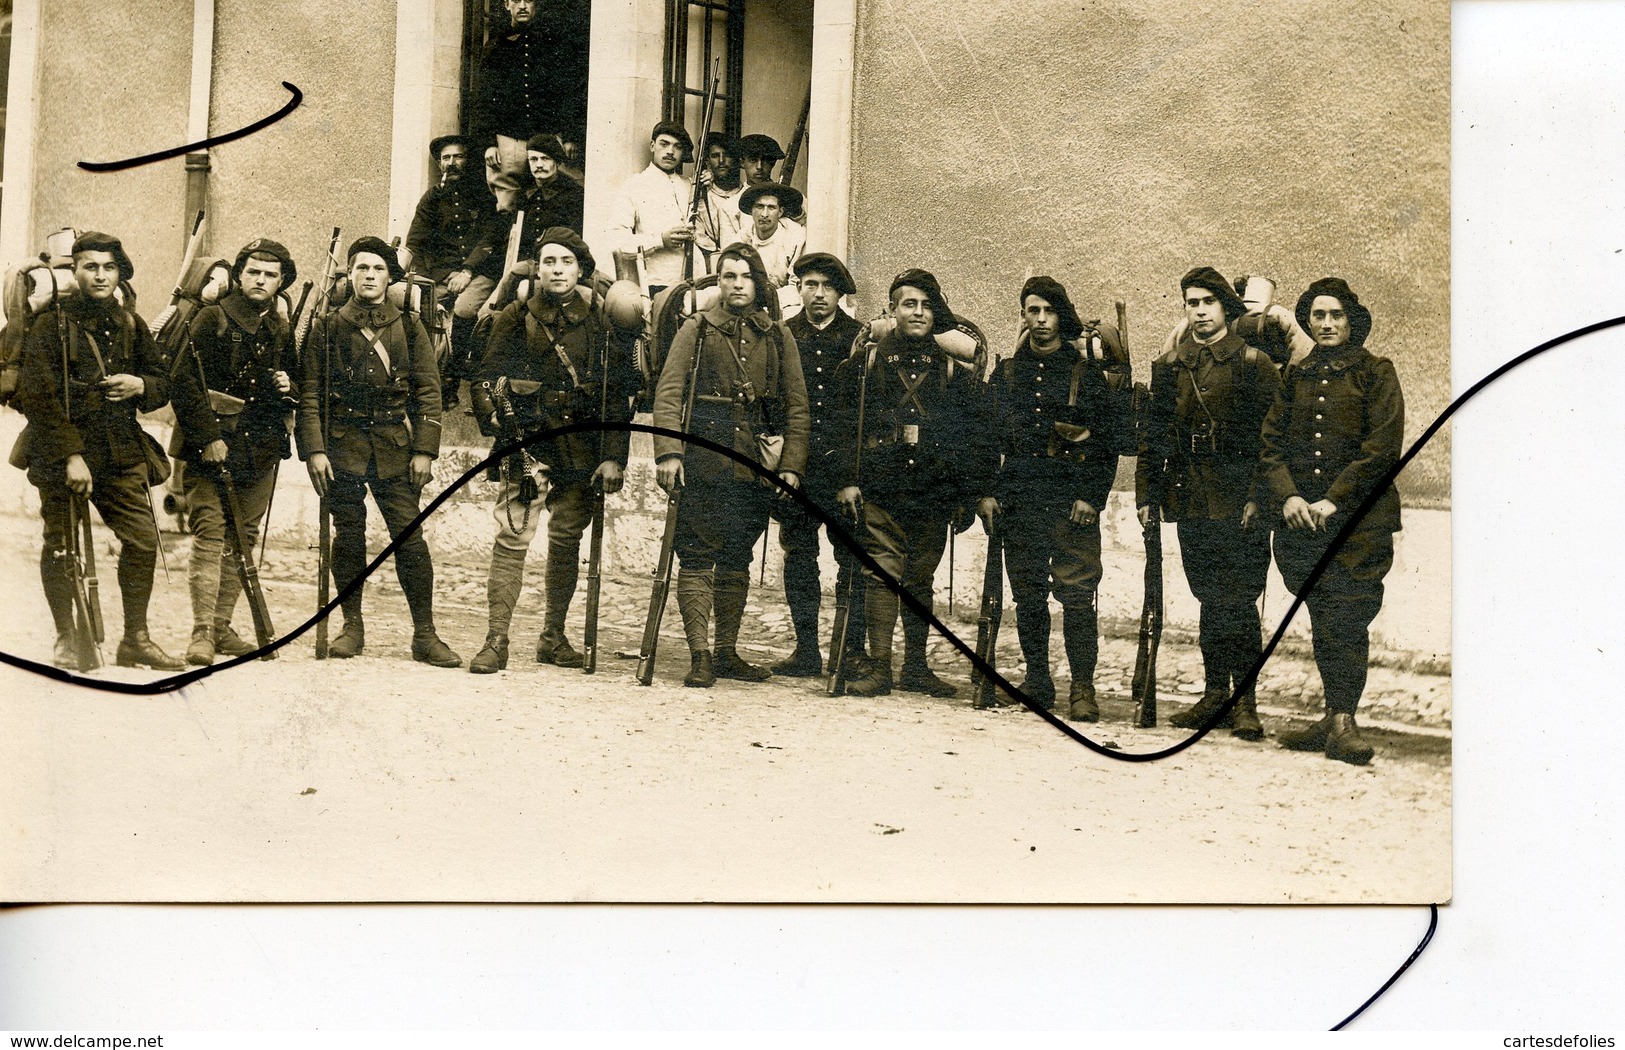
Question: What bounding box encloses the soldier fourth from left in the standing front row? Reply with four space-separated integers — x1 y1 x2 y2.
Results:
468 226 639 675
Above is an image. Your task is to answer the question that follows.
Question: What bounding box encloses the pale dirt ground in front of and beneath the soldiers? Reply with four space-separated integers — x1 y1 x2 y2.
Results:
0 517 1451 902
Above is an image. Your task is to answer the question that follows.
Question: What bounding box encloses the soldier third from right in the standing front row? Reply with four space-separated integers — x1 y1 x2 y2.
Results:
978 276 1129 722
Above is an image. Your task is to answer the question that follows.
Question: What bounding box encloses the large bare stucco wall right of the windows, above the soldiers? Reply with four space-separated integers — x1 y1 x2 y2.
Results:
850 0 1450 499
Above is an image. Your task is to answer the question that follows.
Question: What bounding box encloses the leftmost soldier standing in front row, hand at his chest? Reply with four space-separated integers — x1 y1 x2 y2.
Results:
16 232 185 671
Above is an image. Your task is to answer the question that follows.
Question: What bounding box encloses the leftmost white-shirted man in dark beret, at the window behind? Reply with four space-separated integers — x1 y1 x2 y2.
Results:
609 120 694 293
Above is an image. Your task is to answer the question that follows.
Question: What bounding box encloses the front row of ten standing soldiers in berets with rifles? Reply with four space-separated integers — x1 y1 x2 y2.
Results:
6 190 1404 762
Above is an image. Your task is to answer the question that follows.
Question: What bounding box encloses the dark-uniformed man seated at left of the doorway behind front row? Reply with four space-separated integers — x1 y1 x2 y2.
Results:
406 135 502 408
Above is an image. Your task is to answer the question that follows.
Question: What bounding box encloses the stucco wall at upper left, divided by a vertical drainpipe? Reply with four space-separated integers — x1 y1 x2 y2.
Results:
31 0 395 302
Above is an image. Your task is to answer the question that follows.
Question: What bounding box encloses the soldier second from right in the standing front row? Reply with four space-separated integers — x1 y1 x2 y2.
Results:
1134 267 1281 740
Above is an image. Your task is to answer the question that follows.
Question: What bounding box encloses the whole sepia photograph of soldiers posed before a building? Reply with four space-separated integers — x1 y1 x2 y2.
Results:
0 0 1453 904
